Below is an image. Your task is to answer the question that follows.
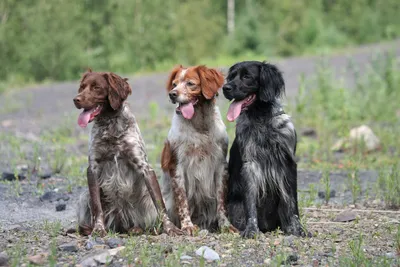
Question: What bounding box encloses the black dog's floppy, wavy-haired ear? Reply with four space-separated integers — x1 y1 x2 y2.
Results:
259 62 285 102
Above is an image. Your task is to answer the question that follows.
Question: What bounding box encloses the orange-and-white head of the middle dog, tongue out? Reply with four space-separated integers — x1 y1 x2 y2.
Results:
167 65 224 120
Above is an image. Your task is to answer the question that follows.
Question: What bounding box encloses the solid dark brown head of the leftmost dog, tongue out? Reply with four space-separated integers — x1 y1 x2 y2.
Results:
74 69 132 128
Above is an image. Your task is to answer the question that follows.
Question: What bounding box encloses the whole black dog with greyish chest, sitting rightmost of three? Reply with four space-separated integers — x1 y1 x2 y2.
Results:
223 61 305 237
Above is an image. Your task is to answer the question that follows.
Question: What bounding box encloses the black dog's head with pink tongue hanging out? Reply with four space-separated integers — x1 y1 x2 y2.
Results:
223 61 285 121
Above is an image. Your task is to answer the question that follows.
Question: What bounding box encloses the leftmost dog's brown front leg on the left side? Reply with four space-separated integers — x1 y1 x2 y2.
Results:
87 165 107 237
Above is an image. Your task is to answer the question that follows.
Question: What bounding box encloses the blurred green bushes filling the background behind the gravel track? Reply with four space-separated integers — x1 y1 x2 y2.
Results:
0 0 400 82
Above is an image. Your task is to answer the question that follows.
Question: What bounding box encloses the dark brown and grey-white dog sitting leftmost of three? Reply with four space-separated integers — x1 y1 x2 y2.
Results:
74 70 182 236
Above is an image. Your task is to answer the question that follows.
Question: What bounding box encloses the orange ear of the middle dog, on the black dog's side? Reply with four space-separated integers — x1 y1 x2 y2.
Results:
197 66 224 99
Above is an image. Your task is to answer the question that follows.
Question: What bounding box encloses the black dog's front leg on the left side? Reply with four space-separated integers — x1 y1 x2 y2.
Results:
242 162 262 238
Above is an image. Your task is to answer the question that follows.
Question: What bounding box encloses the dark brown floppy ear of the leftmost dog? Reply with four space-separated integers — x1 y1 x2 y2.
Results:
103 72 132 110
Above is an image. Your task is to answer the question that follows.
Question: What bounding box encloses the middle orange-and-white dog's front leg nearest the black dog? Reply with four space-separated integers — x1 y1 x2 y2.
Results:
216 163 239 233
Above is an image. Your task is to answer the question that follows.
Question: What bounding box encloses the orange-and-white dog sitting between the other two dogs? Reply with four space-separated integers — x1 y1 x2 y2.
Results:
161 66 237 235
